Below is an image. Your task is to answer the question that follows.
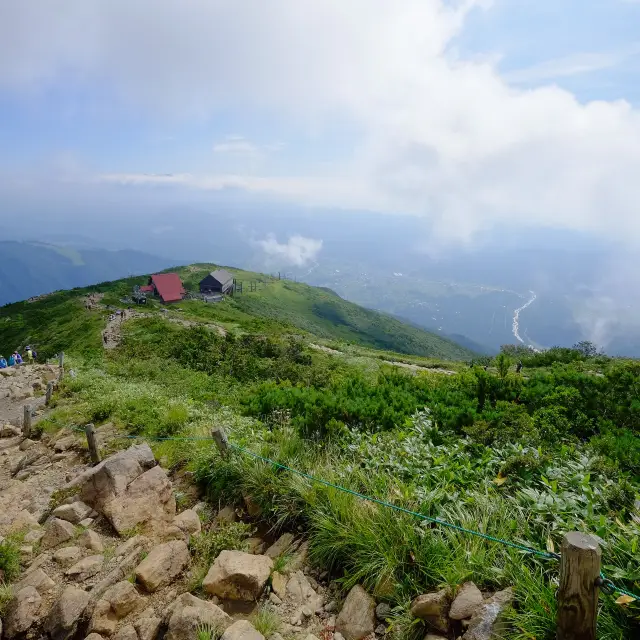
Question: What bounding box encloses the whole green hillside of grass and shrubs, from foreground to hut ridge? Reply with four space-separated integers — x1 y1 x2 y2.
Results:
0 265 640 640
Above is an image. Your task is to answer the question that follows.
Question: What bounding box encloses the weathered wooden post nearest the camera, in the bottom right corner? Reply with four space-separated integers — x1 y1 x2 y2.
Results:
556 531 602 640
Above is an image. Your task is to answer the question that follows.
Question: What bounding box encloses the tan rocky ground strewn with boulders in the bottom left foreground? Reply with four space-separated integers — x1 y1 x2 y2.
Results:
0 425 362 640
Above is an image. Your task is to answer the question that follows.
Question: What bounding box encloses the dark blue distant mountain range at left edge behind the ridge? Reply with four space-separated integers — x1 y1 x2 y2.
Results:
0 242 171 305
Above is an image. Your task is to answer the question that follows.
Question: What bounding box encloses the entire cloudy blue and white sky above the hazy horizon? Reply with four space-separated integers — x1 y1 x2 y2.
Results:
0 0 640 248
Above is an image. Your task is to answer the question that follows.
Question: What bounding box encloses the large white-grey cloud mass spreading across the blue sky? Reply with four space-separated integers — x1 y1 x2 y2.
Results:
0 0 640 248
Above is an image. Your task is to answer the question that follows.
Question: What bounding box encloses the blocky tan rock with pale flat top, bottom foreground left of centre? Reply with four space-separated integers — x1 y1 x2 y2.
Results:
202 551 273 601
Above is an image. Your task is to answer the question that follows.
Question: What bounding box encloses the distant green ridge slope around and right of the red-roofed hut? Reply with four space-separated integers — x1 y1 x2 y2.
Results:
0 265 473 360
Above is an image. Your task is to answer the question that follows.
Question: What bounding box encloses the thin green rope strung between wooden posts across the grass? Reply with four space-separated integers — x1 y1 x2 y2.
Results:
62 425 640 601
